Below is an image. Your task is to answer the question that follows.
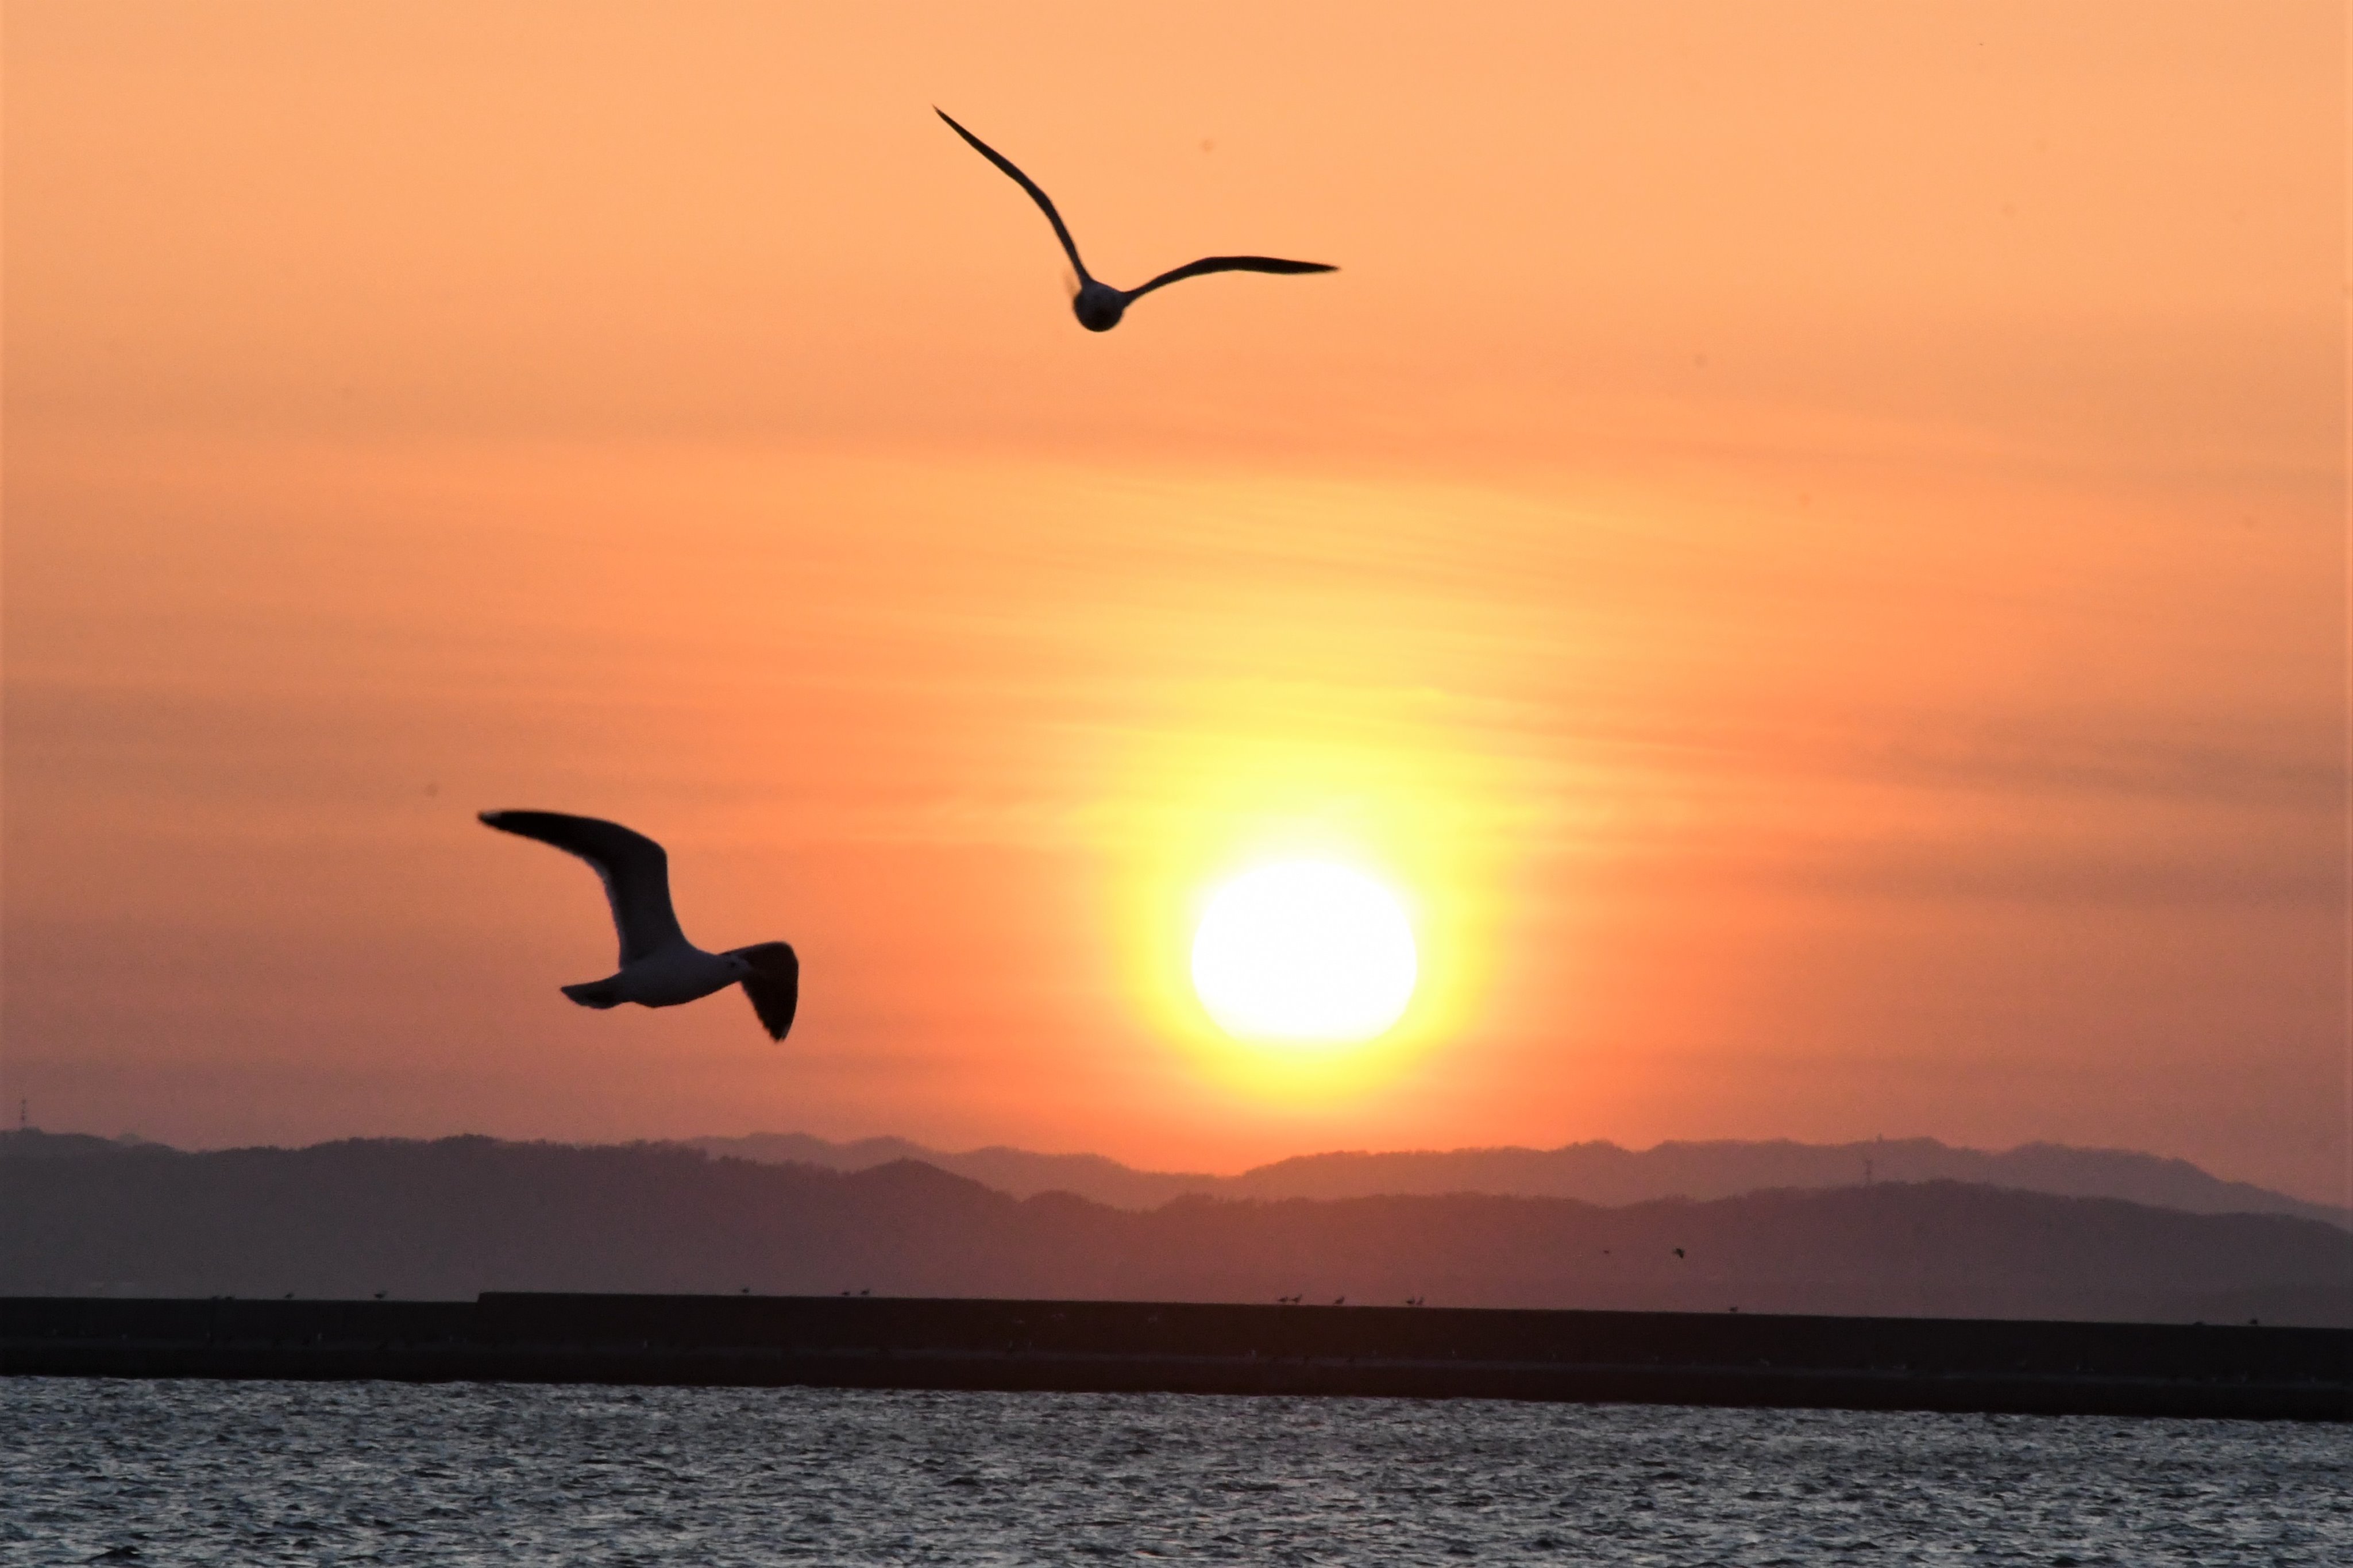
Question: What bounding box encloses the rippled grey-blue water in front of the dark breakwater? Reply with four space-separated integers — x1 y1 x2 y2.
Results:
0 1377 2353 1566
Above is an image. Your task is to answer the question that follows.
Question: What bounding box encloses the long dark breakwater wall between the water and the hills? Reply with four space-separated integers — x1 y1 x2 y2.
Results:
0 1293 2353 1420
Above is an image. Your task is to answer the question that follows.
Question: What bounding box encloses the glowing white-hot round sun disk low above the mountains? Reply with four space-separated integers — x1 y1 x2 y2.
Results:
1193 860 1419 1044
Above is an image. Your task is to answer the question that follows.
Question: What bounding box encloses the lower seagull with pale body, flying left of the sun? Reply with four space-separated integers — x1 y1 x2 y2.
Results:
483 811 800 1039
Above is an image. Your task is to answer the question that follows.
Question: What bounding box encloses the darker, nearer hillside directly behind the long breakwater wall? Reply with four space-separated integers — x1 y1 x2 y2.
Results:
0 1138 2353 1323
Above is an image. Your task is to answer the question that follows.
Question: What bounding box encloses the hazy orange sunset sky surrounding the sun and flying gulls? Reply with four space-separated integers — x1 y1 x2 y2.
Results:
0 0 2346 1196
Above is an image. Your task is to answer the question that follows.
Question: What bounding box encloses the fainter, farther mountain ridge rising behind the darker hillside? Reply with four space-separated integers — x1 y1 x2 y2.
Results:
687 1133 2353 1230
